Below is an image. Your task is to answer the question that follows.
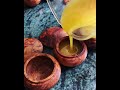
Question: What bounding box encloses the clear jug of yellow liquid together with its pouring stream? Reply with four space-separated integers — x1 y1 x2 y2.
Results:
60 0 96 50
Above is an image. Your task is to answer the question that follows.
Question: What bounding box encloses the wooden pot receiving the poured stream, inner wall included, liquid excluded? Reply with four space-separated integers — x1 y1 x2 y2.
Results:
54 36 88 67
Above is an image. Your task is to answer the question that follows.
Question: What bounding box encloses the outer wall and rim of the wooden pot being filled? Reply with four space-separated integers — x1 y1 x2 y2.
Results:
54 37 88 67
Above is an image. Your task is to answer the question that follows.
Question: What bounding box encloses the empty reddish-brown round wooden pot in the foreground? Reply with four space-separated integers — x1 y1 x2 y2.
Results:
24 53 61 90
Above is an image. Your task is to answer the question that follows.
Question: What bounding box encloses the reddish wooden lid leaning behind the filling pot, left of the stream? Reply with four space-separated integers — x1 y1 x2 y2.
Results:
40 27 67 48
